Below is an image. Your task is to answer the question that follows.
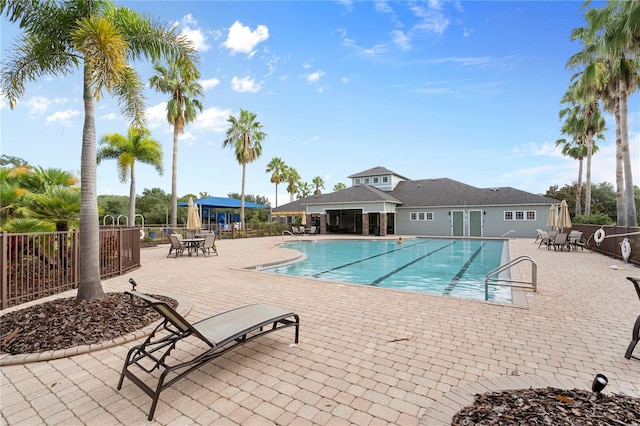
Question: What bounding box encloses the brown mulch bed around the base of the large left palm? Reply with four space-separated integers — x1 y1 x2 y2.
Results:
0 293 178 355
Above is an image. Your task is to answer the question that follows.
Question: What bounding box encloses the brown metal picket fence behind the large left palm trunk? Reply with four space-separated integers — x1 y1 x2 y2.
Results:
0 227 140 309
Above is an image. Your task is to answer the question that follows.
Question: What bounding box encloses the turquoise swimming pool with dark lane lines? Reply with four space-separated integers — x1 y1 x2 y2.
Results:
263 238 511 303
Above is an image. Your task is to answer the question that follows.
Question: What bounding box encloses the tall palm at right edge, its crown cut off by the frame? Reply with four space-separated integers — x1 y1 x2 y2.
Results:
571 1 640 226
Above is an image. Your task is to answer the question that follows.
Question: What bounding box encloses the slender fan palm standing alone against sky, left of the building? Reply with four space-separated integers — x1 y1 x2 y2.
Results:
222 109 267 230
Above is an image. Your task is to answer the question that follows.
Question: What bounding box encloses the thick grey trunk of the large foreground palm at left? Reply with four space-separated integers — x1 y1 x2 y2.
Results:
76 64 104 302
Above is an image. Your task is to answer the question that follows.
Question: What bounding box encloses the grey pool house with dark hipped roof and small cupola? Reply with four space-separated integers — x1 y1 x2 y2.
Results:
272 167 558 237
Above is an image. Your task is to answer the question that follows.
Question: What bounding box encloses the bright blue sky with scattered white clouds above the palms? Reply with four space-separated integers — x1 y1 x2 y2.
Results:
0 0 640 208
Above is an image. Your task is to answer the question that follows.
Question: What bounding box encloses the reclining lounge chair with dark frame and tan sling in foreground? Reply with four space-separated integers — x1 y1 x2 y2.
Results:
118 279 300 421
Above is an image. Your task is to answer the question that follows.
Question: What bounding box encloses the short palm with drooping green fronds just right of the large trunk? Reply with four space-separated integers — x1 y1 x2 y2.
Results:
97 127 164 226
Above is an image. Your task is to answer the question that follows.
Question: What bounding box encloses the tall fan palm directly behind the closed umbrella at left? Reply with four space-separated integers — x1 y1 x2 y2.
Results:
149 61 204 229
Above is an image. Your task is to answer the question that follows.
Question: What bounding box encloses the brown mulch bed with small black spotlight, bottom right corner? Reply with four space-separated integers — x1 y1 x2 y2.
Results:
451 387 640 426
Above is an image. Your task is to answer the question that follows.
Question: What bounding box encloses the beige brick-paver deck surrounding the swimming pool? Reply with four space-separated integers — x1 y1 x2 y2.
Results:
0 236 640 426
